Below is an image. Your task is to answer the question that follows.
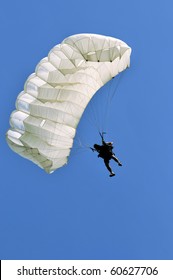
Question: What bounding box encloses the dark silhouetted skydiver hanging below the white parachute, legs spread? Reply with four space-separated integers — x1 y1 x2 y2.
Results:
91 133 122 177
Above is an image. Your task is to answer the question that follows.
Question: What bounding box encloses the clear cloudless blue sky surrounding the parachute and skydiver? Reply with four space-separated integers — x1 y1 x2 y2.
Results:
0 0 173 259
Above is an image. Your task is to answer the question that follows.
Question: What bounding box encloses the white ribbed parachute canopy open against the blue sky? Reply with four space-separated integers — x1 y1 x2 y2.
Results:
7 34 131 173
